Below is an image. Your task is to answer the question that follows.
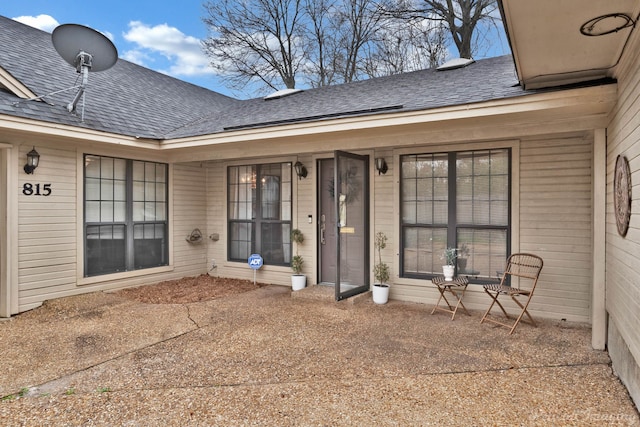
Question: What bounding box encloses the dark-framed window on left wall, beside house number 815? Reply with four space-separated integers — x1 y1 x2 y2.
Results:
84 155 168 277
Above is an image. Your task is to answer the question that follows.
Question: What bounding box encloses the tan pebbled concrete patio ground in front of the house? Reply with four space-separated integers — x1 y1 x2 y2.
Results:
0 286 640 426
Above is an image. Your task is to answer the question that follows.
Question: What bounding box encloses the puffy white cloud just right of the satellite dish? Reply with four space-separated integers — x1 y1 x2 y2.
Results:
122 21 213 76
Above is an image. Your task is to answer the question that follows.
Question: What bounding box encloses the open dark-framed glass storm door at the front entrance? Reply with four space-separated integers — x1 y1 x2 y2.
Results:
333 151 369 300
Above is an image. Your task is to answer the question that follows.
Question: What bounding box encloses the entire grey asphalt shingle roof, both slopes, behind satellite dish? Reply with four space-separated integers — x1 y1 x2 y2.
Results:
0 17 584 140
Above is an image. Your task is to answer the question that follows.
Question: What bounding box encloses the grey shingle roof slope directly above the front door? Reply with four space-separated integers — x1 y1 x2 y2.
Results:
170 56 525 137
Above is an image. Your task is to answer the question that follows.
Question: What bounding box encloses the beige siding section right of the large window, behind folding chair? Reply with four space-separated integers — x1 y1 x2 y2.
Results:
520 136 593 322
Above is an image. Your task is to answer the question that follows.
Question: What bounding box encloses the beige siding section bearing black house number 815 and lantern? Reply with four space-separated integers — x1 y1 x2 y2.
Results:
18 145 77 311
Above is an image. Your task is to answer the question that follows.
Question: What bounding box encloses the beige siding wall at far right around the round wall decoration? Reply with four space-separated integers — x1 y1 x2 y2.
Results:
606 22 640 405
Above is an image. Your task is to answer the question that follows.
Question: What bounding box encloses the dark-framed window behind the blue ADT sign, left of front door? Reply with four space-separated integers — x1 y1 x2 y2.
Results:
227 163 292 265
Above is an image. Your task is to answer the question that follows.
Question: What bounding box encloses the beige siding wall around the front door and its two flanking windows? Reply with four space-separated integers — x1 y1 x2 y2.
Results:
200 132 593 323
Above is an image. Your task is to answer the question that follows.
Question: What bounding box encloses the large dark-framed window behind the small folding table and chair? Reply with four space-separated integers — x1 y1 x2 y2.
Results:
400 149 511 282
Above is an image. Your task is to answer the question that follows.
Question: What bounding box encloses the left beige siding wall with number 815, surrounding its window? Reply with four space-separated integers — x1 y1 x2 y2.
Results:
13 145 207 314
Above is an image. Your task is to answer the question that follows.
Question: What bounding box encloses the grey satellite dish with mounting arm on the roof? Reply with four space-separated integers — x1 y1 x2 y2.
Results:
51 24 118 120
